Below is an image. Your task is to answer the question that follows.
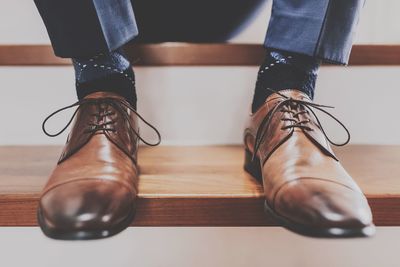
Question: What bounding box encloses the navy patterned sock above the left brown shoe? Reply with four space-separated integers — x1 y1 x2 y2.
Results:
72 49 136 108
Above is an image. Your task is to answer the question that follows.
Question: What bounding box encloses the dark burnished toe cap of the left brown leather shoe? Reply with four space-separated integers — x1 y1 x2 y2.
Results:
39 179 135 239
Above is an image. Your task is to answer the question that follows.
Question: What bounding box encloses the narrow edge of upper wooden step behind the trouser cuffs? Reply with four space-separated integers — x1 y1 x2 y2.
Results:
0 43 400 66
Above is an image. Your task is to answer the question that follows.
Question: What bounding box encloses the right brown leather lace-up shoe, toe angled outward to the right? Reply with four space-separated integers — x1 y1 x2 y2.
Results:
244 90 375 237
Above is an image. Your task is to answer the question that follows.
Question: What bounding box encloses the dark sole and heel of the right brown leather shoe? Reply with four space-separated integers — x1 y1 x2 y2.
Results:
244 149 376 238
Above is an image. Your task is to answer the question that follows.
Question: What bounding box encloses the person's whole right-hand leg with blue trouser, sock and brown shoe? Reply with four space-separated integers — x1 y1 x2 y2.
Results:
244 0 375 237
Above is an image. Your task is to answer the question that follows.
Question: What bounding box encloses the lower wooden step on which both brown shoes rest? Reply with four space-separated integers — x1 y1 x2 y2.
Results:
0 145 400 226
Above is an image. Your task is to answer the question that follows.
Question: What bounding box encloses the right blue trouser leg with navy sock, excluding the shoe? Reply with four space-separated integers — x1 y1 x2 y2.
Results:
252 0 365 112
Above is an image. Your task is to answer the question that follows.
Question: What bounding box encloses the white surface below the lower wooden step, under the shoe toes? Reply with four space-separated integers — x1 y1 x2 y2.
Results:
0 227 400 267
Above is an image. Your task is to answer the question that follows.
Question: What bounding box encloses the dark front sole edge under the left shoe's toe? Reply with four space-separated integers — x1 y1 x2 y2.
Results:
37 204 136 240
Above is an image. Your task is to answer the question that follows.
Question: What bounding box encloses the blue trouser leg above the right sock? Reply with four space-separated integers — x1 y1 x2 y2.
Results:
264 0 365 64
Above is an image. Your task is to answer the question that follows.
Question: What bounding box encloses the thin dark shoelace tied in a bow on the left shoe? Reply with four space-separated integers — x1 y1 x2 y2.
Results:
42 98 161 146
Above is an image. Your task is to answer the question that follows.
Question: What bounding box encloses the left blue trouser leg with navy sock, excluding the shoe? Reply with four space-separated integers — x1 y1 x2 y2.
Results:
35 0 138 108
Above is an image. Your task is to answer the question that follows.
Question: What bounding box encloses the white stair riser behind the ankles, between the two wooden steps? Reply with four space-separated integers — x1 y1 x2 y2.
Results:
0 67 400 145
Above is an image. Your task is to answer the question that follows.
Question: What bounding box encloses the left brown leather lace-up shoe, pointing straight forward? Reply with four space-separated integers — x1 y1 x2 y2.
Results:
38 92 160 239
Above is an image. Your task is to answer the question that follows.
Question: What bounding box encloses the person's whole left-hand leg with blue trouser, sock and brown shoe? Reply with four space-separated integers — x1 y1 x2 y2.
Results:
35 0 160 242
